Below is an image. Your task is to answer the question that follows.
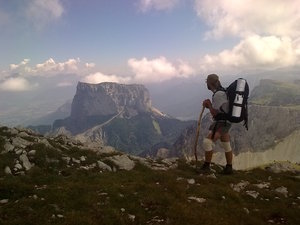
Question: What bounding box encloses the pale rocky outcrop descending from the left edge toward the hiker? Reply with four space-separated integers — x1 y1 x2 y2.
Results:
0 127 178 176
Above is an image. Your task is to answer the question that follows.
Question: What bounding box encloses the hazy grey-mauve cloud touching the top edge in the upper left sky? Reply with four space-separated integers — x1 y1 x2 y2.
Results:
26 0 64 29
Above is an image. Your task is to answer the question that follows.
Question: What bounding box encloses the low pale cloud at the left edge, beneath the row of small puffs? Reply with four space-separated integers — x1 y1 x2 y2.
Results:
0 77 38 92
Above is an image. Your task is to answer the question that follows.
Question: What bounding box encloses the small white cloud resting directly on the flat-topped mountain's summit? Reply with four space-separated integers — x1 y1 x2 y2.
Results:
82 72 130 84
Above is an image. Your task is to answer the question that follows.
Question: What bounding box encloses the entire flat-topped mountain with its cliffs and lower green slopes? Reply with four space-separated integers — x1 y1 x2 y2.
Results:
53 82 193 154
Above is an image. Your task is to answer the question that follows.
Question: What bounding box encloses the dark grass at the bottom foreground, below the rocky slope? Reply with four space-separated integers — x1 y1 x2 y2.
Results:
0 162 300 225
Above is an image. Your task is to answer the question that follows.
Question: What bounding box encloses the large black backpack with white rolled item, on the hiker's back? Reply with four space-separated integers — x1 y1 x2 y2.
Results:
215 78 249 130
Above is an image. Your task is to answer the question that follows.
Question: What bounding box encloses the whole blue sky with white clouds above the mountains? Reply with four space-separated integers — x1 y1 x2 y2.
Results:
0 0 300 92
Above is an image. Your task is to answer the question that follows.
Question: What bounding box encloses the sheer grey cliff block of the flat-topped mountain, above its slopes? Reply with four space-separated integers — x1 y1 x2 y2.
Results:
71 82 151 119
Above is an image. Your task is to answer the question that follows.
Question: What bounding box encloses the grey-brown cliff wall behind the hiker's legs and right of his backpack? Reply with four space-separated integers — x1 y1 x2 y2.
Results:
173 105 300 158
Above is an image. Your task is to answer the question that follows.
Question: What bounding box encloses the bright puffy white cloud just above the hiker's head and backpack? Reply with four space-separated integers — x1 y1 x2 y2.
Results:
201 35 300 70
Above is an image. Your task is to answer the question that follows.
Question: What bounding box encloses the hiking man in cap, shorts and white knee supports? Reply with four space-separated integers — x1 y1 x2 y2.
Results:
201 74 233 174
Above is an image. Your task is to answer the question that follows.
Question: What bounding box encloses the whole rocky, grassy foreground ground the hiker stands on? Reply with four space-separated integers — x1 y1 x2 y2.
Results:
0 127 300 225
